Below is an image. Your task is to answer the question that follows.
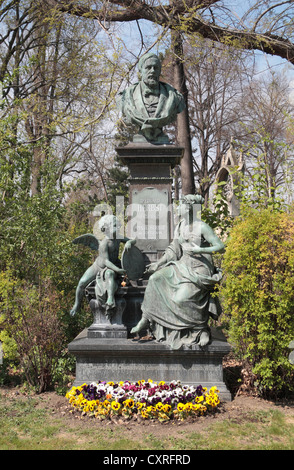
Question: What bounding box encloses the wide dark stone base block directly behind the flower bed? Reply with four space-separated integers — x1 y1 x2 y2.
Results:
68 330 232 401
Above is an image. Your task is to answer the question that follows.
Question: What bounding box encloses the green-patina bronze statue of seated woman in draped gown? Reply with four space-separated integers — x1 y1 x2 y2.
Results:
131 195 224 349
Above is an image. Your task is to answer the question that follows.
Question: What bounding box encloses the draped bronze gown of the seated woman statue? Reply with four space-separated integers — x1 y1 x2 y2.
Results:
142 221 222 349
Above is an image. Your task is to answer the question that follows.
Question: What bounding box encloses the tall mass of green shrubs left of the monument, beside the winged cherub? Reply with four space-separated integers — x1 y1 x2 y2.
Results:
0 117 91 391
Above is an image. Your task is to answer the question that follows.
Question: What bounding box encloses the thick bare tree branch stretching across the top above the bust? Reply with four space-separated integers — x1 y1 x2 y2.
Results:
45 0 294 63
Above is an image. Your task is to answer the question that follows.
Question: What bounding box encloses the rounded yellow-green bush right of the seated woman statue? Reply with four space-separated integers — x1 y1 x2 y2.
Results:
219 208 294 396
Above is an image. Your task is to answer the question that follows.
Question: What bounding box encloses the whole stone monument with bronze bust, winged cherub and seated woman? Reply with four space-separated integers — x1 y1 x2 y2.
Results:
69 54 231 400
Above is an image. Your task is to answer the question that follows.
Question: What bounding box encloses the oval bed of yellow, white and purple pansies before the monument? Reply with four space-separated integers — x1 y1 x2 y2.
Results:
66 379 220 422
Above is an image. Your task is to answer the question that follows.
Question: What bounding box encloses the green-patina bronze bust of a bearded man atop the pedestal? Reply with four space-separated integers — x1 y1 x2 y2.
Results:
119 53 185 144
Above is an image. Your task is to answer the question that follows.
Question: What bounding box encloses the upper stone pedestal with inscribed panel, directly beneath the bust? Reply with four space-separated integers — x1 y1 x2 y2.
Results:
116 143 184 263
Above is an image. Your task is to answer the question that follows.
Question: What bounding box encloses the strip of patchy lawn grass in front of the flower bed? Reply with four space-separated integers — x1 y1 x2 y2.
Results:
0 389 294 451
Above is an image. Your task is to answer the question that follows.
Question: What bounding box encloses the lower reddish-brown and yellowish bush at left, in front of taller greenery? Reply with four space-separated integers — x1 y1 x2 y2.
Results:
0 272 63 392
